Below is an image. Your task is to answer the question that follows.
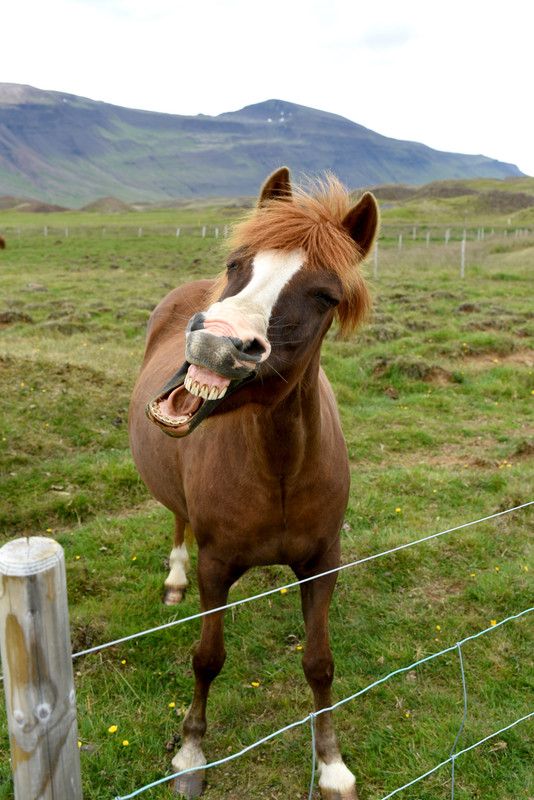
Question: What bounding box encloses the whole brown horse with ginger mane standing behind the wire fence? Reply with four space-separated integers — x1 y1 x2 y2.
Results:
130 167 378 800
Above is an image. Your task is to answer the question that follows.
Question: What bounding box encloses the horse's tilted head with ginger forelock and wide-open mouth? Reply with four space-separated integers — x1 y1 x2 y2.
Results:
147 167 378 437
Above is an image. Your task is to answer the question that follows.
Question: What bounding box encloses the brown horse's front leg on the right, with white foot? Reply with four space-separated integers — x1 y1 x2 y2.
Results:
297 551 358 800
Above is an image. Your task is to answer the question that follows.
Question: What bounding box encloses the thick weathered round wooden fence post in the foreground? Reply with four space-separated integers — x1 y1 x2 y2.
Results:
0 536 82 800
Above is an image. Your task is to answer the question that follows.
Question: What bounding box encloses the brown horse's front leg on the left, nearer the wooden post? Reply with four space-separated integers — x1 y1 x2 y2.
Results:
172 551 232 798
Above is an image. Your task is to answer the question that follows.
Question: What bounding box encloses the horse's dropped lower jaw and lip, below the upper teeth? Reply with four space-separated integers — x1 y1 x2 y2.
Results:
145 361 256 438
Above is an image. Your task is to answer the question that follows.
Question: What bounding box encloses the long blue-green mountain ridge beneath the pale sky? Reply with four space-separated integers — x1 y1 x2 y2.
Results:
0 83 522 206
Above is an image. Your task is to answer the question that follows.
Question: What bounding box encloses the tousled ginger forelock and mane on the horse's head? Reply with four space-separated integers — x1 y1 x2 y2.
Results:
216 175 371 334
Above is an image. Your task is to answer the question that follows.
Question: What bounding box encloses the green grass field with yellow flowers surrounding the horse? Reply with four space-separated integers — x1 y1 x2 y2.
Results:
0 195 534 800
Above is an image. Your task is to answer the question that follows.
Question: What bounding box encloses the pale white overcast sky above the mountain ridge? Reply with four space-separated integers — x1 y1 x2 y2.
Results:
0 0 534 175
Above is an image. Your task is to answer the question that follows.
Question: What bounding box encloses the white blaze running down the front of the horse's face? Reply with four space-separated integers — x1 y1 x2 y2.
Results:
205 248 305 341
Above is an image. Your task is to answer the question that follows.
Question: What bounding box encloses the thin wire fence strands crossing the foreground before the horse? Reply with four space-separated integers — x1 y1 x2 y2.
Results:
2 501 534 800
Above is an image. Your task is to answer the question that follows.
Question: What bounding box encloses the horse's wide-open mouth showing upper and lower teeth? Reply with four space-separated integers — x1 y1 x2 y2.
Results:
146 361 256 437
